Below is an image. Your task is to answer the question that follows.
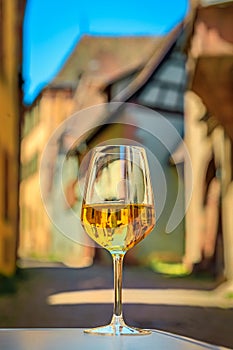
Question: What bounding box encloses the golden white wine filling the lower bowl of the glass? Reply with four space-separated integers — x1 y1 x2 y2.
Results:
81 203 155 253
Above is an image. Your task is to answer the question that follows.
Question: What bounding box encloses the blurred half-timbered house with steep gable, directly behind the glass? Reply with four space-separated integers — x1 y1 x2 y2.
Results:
71 25 186 264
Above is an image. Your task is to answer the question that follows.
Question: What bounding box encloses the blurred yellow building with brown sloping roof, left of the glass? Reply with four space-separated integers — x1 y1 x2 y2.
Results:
19 36 158 264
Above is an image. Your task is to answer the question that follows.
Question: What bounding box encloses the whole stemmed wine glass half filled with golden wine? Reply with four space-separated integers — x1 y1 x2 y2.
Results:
81 145 155 335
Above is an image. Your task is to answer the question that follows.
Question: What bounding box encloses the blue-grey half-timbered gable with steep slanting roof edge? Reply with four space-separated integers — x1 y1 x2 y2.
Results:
103 26 186 114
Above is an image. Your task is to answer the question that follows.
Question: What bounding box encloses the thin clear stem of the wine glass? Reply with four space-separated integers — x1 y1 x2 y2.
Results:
112 254 124 317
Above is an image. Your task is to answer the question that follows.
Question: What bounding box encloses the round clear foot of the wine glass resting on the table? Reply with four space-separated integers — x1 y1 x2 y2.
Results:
84 315 151 335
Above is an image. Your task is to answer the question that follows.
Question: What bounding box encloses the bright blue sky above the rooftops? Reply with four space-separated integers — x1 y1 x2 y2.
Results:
23 0 188 105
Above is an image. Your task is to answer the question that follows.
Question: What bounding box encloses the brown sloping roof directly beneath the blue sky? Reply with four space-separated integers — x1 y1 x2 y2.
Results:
50 35 163 86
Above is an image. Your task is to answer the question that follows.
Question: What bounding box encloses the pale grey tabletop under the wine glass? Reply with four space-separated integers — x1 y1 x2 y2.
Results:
0 328 229 350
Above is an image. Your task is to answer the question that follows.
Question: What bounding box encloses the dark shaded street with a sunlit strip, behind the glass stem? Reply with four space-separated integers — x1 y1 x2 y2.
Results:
0 263 233 348
